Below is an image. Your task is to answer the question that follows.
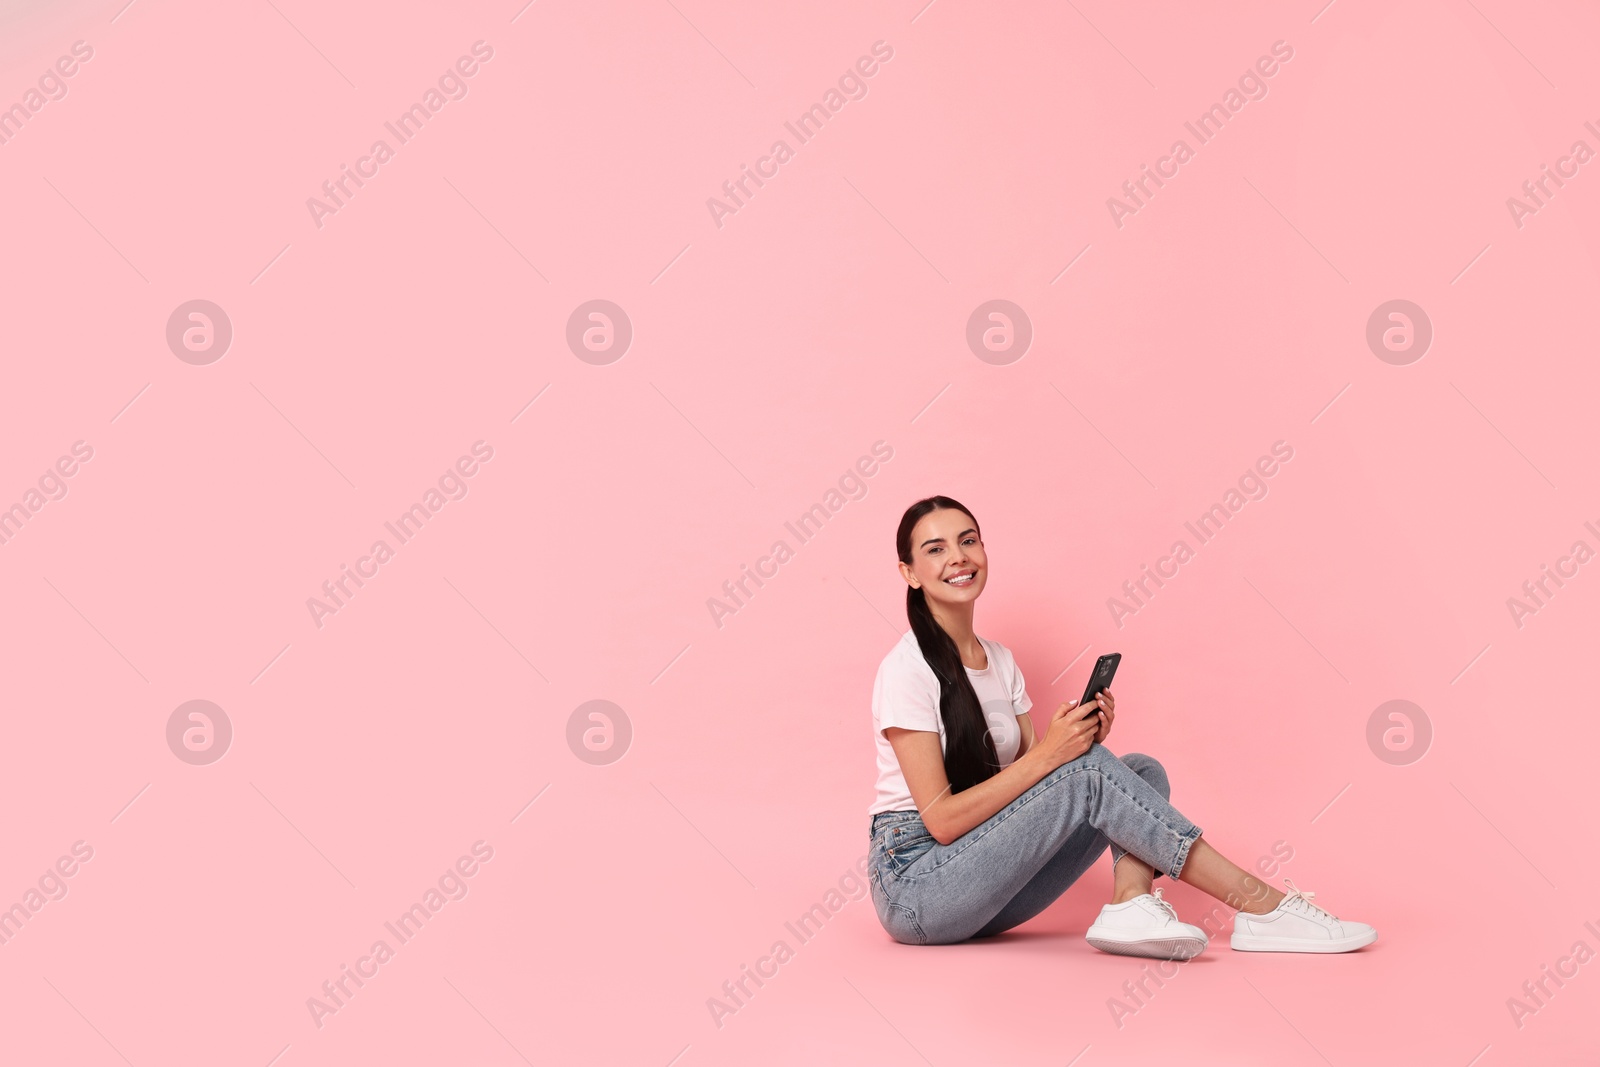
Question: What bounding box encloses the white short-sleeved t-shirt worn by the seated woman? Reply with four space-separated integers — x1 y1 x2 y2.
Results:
867 630 1034 816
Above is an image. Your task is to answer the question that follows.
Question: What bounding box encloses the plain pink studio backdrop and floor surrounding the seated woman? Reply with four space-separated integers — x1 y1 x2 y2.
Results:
0 0 1600 1067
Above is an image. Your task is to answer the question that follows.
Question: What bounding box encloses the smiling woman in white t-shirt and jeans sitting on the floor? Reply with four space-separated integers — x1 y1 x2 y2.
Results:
869 496 1378 960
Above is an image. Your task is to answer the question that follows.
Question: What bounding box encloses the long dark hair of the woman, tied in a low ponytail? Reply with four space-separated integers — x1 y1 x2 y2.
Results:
894 496 1000 793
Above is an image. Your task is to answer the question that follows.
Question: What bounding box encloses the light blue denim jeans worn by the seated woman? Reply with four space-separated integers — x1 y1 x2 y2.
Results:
869 744 1200 945
